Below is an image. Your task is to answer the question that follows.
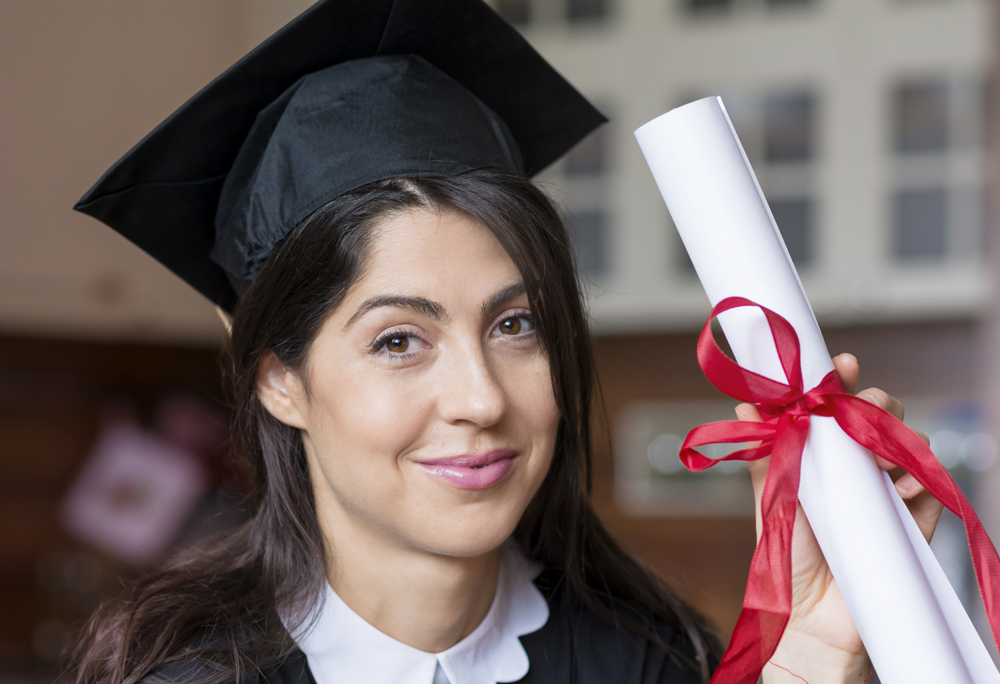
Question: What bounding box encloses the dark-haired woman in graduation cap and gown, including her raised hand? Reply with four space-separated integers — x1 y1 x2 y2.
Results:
64 0 940 684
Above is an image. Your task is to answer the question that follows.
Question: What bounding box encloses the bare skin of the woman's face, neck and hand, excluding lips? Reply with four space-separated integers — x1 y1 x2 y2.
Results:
258 204 941 684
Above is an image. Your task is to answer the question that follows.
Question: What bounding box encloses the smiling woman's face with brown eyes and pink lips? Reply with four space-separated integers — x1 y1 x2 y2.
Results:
262 210 559 556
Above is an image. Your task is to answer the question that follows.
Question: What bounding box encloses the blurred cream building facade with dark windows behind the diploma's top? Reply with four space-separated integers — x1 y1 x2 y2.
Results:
495 0 992 334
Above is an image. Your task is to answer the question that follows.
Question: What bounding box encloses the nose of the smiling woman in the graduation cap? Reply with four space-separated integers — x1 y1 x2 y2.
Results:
438 345 507 427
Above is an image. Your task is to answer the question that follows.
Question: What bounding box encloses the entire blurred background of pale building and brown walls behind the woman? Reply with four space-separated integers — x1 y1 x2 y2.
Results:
0 0 1000 684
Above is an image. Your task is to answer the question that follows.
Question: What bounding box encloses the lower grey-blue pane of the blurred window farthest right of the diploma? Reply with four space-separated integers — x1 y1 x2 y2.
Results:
893 188 948 261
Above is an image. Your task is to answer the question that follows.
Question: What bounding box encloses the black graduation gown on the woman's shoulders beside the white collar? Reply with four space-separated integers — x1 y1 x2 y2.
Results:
154 571 701 684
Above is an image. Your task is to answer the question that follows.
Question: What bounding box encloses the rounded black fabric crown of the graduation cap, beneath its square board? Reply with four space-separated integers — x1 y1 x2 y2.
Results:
211 55 523 293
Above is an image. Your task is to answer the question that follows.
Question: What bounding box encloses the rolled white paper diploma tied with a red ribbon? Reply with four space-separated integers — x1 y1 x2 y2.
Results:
635 98 1000 684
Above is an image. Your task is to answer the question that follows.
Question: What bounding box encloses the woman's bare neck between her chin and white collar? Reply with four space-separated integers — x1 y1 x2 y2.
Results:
316 480 500 653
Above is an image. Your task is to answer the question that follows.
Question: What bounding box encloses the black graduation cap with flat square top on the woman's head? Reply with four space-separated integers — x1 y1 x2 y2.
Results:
74 0 606 310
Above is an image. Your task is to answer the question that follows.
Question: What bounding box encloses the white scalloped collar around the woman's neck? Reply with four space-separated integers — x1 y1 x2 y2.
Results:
296 543 549 684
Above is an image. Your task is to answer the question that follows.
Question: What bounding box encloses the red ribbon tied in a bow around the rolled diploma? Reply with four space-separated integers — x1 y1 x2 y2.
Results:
680 297 1000 684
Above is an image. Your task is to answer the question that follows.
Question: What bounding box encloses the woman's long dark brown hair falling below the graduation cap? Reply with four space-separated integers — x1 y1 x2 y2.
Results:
71 170 721 684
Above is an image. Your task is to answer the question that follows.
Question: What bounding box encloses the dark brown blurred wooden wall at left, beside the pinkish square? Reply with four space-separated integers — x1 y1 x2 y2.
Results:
0 338 222 679
